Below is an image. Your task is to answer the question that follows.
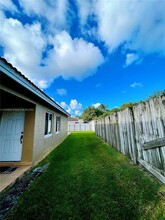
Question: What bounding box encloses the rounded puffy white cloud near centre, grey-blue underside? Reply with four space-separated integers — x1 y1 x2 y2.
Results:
45 31 104 80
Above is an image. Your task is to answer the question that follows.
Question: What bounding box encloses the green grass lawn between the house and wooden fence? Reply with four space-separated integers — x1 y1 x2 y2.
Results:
7 132 165 220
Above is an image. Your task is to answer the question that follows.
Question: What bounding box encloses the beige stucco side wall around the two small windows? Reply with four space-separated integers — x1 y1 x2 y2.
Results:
33 104 68 165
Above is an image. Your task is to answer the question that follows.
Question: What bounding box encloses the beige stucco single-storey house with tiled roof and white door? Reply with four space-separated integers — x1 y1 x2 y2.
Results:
0 58 70 166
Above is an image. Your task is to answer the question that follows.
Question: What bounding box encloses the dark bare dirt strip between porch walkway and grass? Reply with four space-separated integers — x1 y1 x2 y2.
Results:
0 164 49 220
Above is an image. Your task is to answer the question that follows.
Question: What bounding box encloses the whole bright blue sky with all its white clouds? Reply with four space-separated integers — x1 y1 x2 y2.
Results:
0 0 165 115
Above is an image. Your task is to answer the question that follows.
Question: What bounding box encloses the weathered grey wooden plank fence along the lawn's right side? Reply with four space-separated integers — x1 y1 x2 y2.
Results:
95 96 165 184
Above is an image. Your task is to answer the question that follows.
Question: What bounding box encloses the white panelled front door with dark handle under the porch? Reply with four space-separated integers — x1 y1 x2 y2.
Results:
0 111 24 161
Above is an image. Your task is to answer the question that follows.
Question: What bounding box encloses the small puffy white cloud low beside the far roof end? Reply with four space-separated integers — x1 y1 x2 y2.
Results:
60 99 82 116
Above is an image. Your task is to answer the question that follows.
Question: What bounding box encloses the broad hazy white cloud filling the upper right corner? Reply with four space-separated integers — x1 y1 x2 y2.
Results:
95 0 165 55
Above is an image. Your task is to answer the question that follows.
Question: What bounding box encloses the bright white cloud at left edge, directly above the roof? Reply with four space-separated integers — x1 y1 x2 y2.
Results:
0 15 46 84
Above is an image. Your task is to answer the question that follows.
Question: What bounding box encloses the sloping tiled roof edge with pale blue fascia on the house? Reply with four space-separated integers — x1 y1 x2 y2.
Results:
0 57 70 116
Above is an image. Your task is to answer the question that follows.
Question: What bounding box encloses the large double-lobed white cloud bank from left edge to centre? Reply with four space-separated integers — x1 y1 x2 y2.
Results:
0 14 104 89
